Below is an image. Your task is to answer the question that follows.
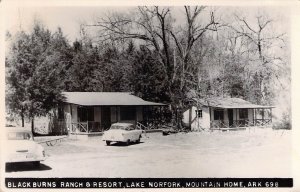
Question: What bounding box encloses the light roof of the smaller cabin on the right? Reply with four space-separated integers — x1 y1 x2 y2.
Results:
199 98 274 109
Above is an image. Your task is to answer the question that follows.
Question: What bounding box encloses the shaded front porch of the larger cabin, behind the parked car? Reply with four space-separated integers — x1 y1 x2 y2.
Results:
67 106 164 133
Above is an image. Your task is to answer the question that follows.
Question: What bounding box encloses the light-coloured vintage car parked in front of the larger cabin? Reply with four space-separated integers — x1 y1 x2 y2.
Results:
102 123 143 145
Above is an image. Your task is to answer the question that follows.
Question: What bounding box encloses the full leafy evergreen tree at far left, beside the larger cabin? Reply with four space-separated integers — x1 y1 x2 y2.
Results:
6 22 68 132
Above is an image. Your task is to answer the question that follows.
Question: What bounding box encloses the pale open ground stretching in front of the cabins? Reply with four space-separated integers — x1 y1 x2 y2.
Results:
6 128 292 177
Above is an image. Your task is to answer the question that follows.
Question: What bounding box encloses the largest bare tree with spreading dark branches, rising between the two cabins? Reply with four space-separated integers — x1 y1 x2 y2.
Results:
94 6 220 89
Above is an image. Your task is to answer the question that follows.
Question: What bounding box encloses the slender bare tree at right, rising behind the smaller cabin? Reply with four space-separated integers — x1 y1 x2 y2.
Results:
231 11 285 103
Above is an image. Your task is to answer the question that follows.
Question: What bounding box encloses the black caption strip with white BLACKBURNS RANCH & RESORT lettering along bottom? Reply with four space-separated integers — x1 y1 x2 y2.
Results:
5 178 293 188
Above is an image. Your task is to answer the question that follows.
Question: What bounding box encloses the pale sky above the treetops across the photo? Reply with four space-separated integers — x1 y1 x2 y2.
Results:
5 6 289 42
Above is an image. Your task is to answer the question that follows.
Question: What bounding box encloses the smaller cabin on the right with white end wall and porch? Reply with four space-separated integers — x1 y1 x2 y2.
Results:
182 98 274 131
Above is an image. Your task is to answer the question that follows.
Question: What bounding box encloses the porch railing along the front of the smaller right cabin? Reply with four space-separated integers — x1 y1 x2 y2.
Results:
210 119 272 128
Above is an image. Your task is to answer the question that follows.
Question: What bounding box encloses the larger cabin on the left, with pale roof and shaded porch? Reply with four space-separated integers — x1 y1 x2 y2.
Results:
56 92 166 133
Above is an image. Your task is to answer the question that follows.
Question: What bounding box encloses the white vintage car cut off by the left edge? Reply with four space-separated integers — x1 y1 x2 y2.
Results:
4 127 46 166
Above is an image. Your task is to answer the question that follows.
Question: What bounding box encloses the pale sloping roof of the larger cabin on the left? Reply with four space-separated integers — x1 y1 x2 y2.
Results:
62 92 165 106
